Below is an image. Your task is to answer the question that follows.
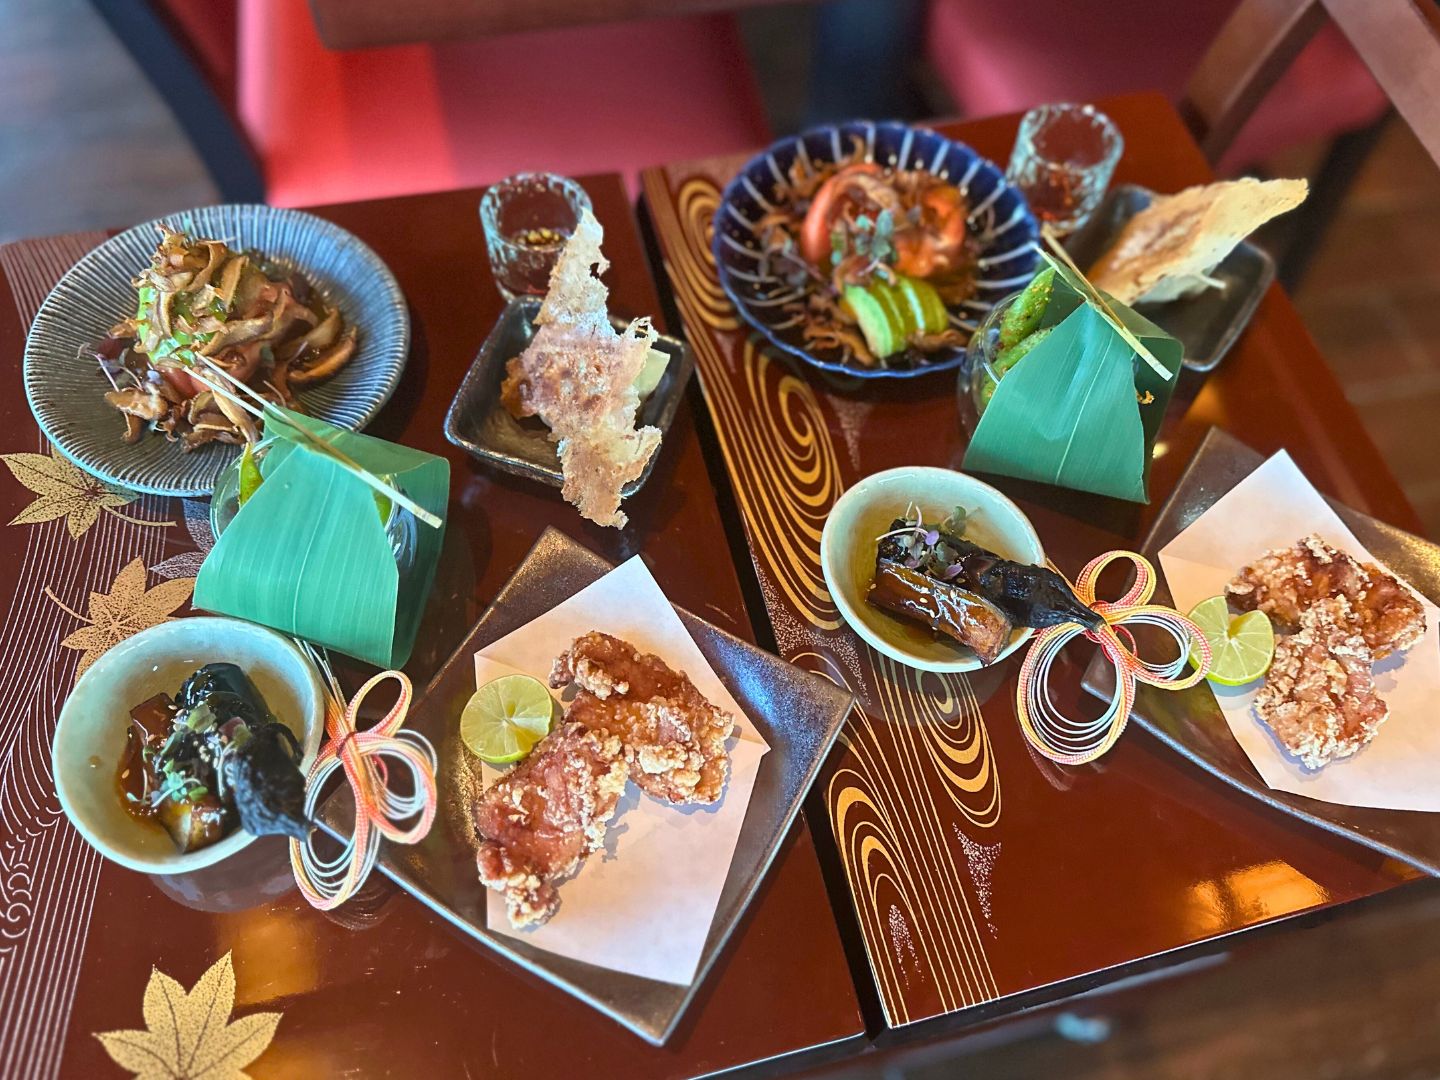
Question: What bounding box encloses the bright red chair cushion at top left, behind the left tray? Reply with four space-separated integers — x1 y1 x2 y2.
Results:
239 0 769 206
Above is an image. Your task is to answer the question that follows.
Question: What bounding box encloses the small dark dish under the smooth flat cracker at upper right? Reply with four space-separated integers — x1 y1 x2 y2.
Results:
1066 184 1274 372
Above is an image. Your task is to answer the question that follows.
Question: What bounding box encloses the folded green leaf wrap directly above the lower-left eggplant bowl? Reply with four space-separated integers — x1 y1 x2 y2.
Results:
194 409 449 668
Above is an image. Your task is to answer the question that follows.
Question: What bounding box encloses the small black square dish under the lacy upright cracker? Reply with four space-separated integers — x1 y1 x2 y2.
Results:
445 297 696 498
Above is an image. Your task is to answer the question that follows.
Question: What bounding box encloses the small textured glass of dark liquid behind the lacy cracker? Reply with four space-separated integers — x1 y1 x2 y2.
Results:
480 173 590 300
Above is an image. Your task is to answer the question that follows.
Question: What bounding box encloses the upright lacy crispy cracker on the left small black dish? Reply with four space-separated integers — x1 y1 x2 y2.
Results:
501 210 660 528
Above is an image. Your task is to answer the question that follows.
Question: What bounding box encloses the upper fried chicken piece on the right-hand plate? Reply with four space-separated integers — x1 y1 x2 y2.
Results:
1225 536 1426 660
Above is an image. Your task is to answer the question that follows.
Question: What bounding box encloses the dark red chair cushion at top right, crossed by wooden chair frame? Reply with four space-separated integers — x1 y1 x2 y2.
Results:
927 0 1387 171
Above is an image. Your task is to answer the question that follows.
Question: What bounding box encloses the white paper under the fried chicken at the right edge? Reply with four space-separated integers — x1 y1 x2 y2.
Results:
1161 451 1440 811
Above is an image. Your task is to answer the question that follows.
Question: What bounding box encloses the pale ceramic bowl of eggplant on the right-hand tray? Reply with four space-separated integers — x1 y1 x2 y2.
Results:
819 465 1045 671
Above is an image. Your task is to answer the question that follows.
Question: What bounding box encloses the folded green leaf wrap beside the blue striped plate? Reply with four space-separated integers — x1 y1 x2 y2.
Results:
963 274 1184 503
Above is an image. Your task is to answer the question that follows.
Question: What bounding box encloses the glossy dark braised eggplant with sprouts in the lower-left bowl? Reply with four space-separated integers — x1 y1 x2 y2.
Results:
117 664 308 852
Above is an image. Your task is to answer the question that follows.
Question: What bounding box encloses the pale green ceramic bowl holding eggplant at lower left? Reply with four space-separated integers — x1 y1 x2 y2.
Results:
52 616 325 874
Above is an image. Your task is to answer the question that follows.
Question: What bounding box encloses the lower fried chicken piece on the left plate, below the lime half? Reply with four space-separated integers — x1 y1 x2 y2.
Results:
475 723 626 927
